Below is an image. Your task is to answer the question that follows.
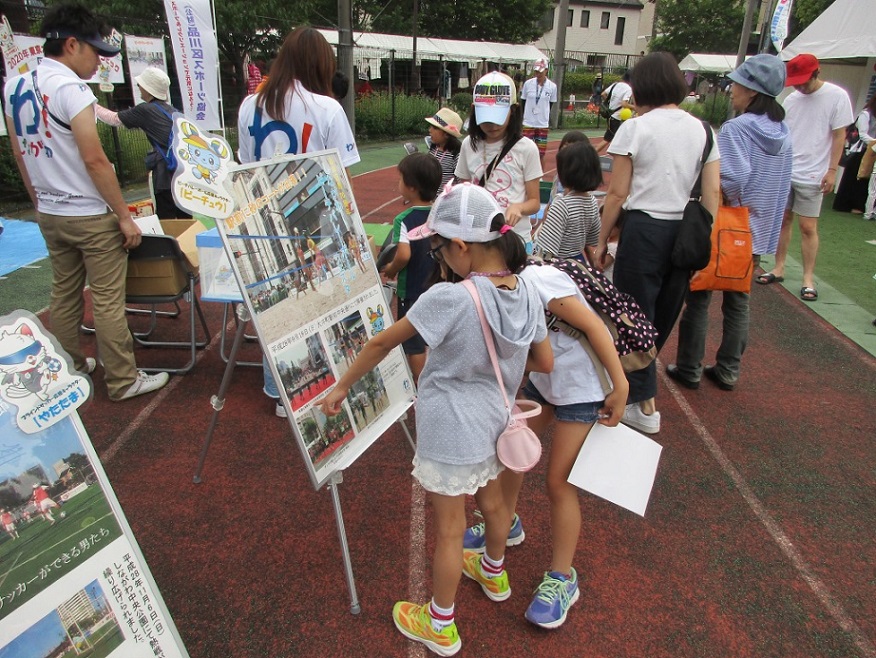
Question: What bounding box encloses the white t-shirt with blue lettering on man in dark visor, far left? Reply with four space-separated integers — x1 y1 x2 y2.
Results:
3 57 107 217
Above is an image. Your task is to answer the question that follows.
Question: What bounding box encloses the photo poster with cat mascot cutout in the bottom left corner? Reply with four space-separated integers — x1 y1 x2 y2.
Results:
0 311 188 658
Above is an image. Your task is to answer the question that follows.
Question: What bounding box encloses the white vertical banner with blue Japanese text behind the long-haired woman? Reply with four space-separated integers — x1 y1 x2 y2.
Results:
164 0 222 130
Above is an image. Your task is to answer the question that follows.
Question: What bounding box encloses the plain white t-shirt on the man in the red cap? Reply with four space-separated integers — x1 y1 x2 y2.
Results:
782 82 854 185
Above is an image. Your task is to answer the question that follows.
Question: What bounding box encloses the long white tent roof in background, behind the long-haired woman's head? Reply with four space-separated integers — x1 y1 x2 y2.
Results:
320 30 548 64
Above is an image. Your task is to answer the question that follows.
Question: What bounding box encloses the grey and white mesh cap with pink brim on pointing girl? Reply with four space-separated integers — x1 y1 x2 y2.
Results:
408 183 505 242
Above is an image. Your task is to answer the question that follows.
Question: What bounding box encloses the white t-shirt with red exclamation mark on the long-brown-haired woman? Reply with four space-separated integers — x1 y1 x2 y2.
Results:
237 81 360 167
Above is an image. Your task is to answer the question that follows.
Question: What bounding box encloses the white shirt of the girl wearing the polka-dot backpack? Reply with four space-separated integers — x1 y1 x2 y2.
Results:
520 265 611 405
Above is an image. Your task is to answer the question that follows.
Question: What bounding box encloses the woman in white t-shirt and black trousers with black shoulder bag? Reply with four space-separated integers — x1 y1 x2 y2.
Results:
596 53 720 434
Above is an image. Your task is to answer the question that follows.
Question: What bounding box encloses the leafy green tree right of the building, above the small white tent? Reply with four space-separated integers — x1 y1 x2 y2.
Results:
650 0 745 59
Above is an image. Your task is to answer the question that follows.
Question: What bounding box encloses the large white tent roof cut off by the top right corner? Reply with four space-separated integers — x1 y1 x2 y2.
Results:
782 0 876 60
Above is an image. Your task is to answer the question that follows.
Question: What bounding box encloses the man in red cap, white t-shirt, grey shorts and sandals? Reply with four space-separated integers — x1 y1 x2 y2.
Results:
756 53 854 302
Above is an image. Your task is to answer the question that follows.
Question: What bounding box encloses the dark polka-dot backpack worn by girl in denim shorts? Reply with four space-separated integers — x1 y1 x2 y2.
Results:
527 258 657 390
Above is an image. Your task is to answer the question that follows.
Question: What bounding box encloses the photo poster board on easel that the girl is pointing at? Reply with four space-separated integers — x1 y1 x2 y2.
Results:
217 150 414 488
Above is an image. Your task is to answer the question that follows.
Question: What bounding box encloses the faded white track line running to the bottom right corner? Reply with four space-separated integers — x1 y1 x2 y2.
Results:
658 362 876 658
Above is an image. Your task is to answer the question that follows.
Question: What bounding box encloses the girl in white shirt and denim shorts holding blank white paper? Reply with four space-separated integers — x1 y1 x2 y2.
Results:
464 265 628 628
